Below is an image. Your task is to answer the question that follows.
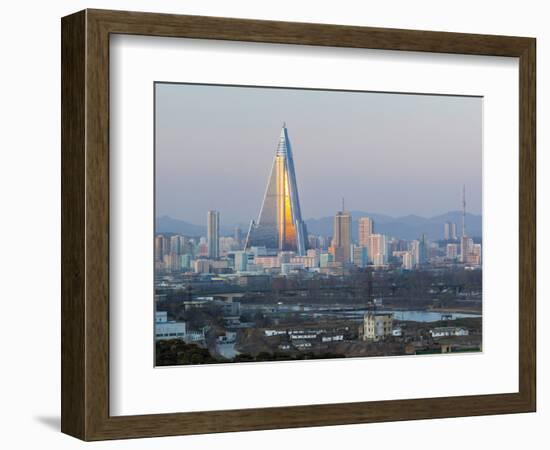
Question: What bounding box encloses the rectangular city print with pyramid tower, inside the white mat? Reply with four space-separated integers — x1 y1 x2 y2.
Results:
154 84 483 366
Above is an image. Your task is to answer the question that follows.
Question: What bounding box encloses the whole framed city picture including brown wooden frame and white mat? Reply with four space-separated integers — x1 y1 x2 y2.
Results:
61 10 536 440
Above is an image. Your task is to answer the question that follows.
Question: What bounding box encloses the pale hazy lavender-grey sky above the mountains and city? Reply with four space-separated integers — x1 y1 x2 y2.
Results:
155 84 482 225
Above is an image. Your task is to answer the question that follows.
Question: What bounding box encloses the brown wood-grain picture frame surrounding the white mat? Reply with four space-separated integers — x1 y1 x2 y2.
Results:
61 10 536 440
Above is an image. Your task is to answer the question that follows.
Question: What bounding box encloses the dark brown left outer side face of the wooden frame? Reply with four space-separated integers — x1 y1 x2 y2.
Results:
61 12 86 437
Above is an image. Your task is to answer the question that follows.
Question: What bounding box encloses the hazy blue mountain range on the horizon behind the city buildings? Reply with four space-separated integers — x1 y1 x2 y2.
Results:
156 211 482 240
